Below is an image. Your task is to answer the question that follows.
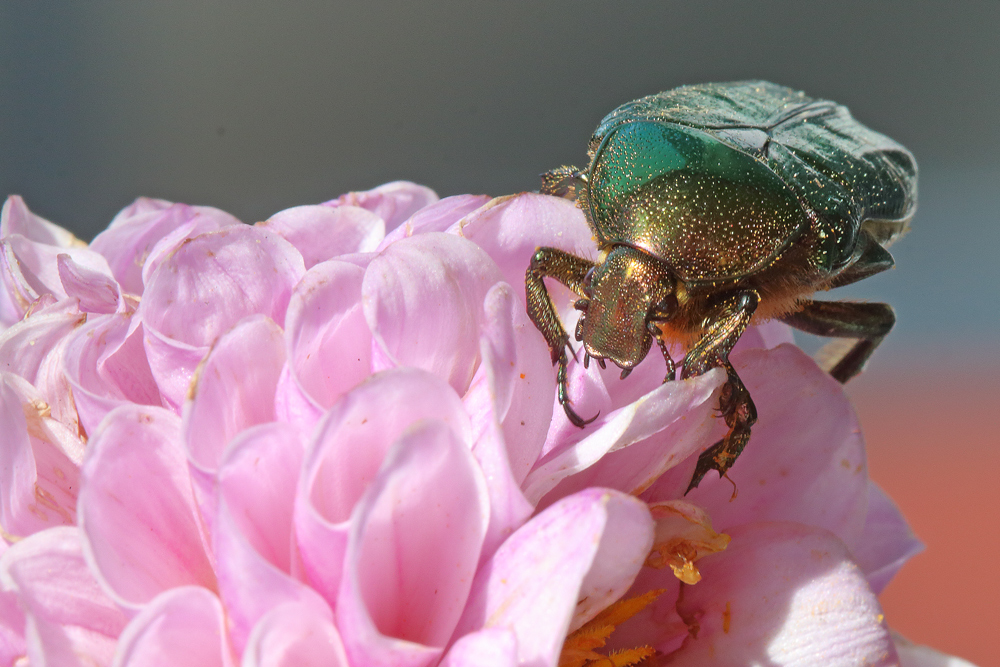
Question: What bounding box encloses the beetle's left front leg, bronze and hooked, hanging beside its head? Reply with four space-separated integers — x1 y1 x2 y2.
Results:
524 248 597 428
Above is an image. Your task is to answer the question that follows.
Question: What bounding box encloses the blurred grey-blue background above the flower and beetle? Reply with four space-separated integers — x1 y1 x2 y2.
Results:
0 0 1000 356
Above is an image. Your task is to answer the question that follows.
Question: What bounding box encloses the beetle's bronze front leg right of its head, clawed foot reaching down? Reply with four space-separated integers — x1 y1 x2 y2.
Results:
683 290 760 493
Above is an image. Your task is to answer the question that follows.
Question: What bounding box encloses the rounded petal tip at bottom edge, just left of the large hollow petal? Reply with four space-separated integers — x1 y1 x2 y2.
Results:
241 603 349 667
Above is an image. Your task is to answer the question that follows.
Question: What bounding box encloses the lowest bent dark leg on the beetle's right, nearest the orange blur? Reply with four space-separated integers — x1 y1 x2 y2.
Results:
781 301 896 383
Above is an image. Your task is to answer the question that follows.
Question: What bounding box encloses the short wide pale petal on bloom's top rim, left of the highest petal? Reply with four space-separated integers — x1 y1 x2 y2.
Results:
256 206 385 269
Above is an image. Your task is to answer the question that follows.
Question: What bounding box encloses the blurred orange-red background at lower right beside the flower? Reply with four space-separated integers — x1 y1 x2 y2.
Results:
848 360 1000 667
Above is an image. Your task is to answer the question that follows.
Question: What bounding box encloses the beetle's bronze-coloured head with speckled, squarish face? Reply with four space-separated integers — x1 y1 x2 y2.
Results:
579 245 677 370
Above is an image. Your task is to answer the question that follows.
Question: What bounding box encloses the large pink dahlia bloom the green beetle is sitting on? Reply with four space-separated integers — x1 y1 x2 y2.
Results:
0 183 972 667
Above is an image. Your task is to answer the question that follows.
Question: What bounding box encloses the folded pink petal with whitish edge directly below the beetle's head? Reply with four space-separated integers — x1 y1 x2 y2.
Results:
522 371 725 503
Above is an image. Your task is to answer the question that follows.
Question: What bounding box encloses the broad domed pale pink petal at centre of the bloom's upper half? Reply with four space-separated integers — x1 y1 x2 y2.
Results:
362 232 500 395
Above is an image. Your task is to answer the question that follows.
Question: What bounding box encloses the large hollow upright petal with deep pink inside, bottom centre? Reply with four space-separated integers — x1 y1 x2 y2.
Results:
336 420 489 665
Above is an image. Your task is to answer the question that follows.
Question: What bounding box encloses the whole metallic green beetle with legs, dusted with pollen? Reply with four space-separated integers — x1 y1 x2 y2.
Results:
525 81 917 490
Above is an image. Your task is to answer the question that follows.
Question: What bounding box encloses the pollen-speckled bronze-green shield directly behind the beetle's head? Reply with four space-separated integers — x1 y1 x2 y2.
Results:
587 122 809 282
